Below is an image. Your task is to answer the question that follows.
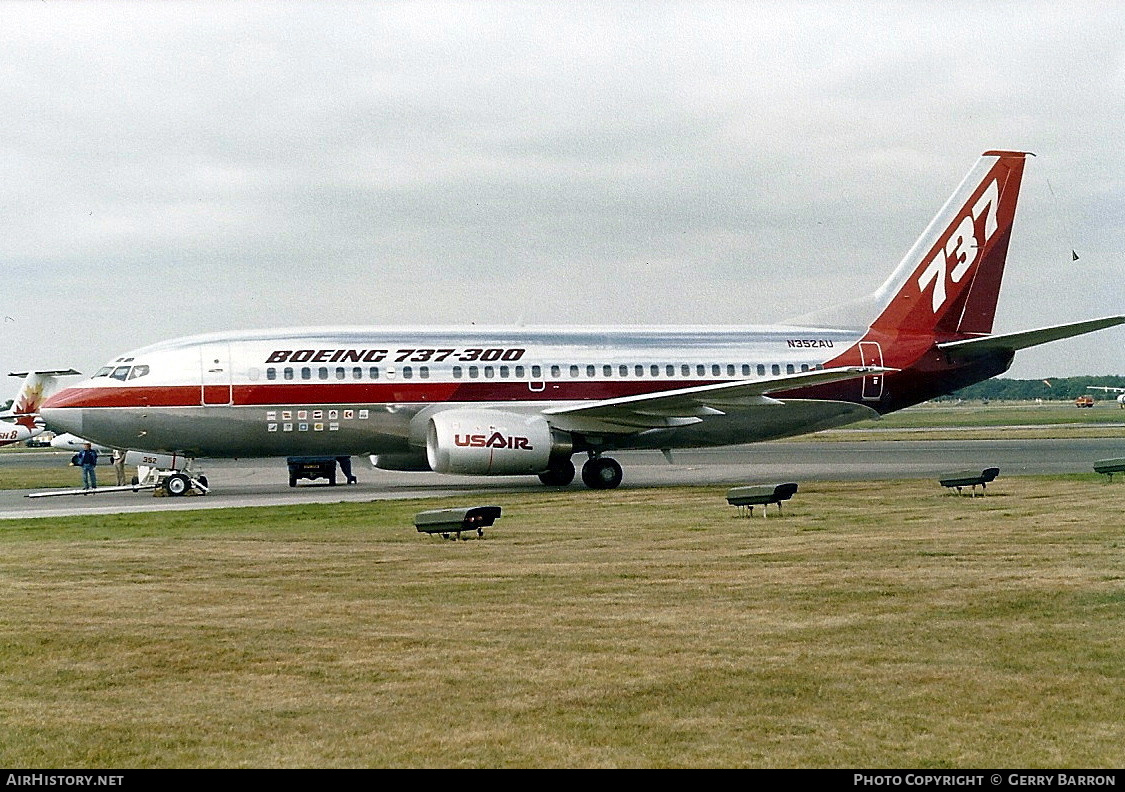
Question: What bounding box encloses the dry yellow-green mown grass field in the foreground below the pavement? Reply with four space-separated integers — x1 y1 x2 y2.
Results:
0 475 1125 767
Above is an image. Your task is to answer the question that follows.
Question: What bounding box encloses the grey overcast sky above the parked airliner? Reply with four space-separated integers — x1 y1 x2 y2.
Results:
0 0 1125 380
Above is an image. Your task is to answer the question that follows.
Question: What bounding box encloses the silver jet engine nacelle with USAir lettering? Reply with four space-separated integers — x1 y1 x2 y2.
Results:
425 410 570 476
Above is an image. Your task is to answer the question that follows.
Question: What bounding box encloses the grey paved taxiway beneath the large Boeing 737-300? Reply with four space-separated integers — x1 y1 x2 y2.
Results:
0 437 1125 519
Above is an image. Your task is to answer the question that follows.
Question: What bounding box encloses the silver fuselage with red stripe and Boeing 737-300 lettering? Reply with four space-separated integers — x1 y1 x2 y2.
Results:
43 326 958 457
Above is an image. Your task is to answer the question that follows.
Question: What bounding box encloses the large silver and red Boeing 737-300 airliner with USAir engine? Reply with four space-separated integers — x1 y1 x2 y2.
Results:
43 151 1125 489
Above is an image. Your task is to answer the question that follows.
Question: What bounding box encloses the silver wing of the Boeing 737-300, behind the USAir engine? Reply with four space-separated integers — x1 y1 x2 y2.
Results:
543 366 896 434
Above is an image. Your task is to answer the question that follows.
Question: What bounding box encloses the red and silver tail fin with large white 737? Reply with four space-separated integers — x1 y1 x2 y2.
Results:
871 151 1026 338
